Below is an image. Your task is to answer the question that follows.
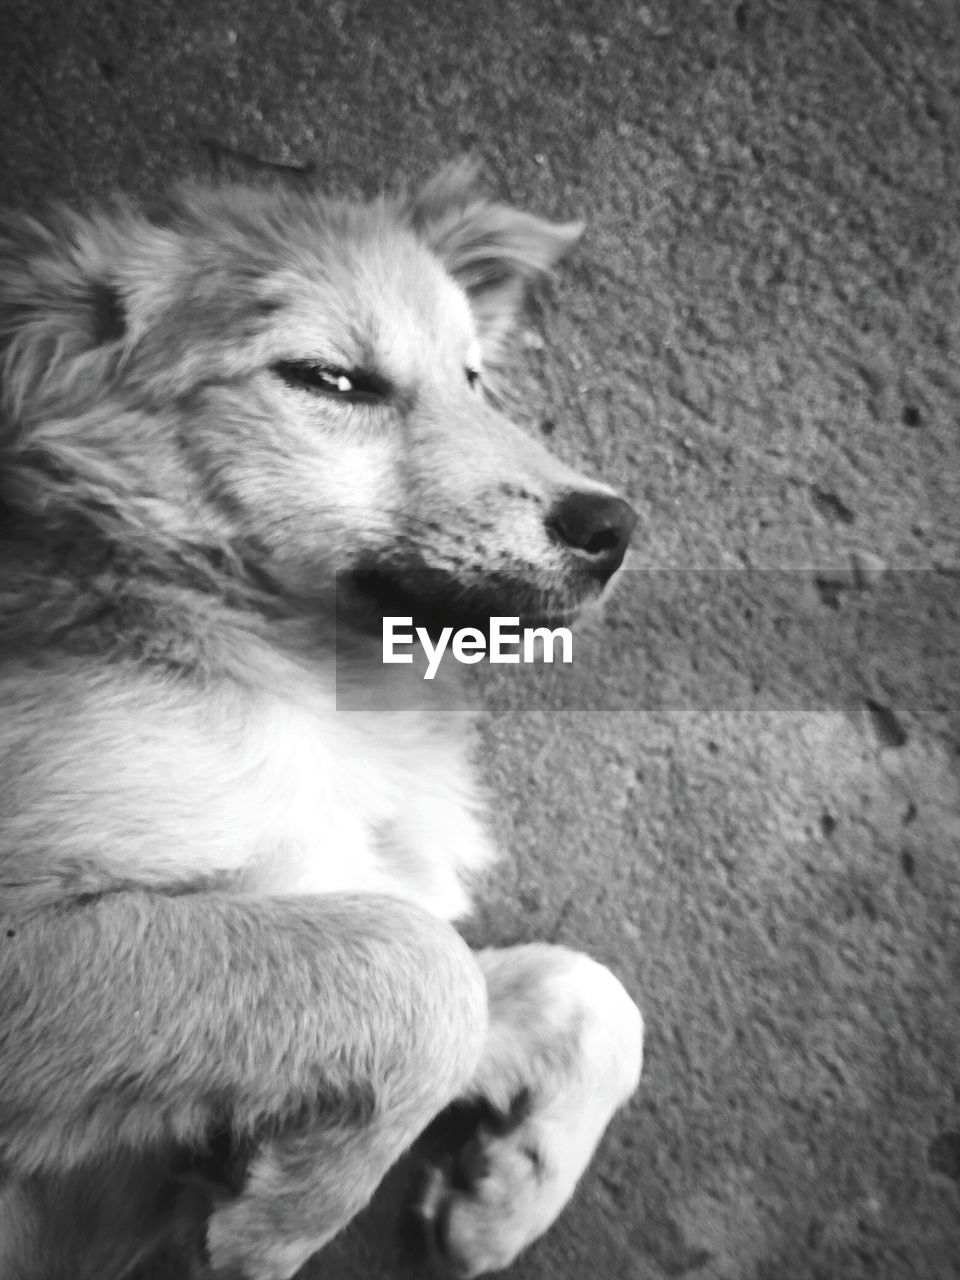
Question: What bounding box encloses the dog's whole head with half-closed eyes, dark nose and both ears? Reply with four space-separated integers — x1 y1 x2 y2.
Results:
0 166 635 621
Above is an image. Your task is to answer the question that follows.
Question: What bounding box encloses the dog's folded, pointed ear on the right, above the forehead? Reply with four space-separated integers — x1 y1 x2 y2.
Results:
404 159 584 358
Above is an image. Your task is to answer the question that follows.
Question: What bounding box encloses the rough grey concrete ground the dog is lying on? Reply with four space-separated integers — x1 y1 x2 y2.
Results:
0 0 960 1280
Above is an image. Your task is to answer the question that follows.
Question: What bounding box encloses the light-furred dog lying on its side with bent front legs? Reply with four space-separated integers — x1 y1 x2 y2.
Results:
0 163 643 1280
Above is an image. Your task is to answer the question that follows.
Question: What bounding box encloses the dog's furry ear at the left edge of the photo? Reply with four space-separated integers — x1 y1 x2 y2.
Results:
0 210 127 422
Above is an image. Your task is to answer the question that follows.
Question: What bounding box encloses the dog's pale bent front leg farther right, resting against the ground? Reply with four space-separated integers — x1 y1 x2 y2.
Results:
420 945 643 1280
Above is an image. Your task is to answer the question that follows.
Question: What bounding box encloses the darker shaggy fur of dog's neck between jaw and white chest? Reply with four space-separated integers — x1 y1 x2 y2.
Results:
0 503 458 709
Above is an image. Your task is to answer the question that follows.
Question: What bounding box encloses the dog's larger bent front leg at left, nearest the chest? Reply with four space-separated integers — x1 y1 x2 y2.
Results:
0 892 486 1280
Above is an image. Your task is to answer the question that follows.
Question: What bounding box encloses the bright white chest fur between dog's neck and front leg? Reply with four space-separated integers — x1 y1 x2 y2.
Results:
0 669 490 918
